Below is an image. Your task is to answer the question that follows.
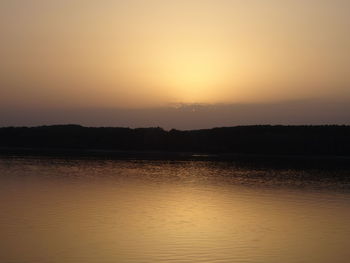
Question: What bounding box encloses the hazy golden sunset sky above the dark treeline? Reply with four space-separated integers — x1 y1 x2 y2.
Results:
0 0 350 129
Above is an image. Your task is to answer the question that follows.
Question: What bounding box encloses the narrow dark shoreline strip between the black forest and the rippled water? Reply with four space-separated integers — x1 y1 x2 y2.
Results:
0 147 350 169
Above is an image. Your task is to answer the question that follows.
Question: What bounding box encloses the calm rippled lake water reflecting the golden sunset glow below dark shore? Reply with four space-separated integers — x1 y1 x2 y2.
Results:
0 158 350 263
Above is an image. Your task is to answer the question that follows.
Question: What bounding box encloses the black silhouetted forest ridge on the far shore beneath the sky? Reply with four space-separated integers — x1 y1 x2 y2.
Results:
0 125 350 156
